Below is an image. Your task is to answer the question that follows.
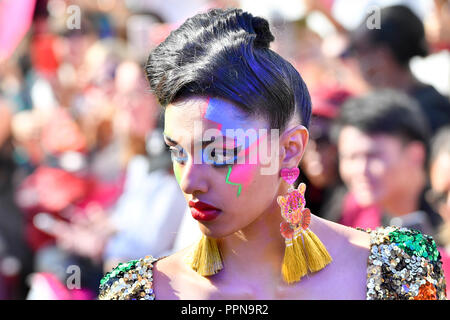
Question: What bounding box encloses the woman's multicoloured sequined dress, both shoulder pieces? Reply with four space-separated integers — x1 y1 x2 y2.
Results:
98 227 446 300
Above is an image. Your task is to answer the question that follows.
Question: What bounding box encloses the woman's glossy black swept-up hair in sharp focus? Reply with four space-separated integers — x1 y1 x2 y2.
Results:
146 9 311 130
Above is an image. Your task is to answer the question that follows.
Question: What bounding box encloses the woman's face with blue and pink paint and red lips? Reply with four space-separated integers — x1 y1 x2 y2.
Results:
164 97 298 238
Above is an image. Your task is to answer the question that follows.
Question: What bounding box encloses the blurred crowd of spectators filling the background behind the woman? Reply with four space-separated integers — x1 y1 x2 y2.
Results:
0 0 450 299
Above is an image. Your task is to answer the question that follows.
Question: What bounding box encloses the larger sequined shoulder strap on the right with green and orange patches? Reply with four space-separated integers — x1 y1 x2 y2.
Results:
367 227 446 300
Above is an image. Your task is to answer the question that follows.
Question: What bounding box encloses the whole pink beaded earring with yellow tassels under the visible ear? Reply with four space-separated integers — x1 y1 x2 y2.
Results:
277 168 332 283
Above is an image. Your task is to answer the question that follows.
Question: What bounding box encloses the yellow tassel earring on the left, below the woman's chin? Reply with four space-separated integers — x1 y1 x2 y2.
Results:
186 235 223 276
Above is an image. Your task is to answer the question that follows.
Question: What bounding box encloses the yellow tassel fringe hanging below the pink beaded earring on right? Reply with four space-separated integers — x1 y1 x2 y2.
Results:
281 229 332 284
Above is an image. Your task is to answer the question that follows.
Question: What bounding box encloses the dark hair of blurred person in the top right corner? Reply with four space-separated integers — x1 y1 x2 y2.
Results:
352 5 428 65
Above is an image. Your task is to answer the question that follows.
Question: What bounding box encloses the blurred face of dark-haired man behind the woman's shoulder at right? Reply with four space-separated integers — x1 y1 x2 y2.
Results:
338 126 425 216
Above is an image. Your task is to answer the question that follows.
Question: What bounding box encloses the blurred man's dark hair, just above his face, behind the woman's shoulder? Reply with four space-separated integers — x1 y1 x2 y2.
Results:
332 89 430 148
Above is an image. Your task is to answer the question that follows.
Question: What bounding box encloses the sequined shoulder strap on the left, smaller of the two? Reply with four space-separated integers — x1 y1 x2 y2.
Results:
98 256 159 300
